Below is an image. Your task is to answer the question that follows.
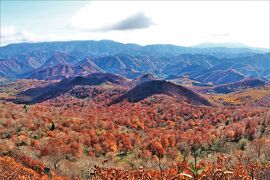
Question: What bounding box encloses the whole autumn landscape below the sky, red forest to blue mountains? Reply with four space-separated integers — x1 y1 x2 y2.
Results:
0 41 270 179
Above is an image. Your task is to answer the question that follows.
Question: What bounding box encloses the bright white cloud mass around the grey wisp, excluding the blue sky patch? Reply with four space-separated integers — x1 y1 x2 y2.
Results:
1 1 270 48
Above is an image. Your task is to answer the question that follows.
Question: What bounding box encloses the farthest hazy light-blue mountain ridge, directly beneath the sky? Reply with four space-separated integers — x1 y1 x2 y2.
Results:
0 40 265 59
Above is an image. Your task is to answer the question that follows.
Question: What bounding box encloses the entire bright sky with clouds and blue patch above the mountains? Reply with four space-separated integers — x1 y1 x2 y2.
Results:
0 0 270 48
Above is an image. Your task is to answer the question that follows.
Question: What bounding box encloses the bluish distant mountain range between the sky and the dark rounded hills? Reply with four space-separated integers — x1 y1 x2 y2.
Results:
0 40 270 85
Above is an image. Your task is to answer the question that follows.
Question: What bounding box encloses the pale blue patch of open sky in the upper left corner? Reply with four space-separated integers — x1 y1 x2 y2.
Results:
1 0 88 34
